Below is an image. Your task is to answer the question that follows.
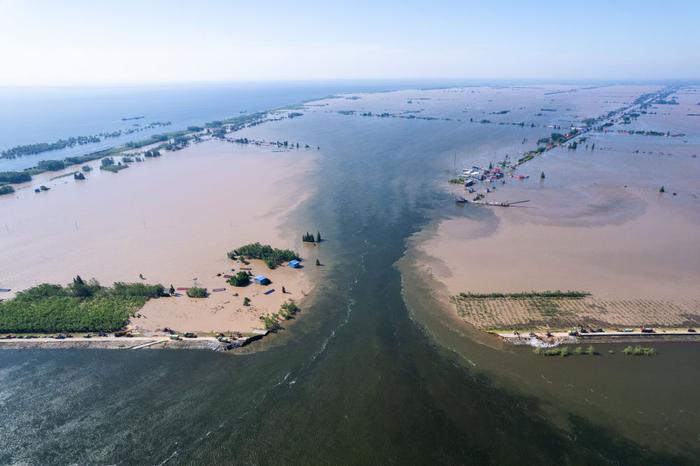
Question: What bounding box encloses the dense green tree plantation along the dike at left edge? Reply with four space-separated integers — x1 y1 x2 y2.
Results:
0 276 164 333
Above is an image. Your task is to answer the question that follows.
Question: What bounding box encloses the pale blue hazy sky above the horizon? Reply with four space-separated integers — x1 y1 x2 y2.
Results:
0 0 700 85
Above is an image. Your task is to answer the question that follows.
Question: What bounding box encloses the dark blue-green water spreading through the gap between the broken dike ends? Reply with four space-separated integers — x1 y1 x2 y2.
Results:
0 108 693 464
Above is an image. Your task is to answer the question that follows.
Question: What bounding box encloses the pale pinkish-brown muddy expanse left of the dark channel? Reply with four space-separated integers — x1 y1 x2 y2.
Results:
0 141 317 333
